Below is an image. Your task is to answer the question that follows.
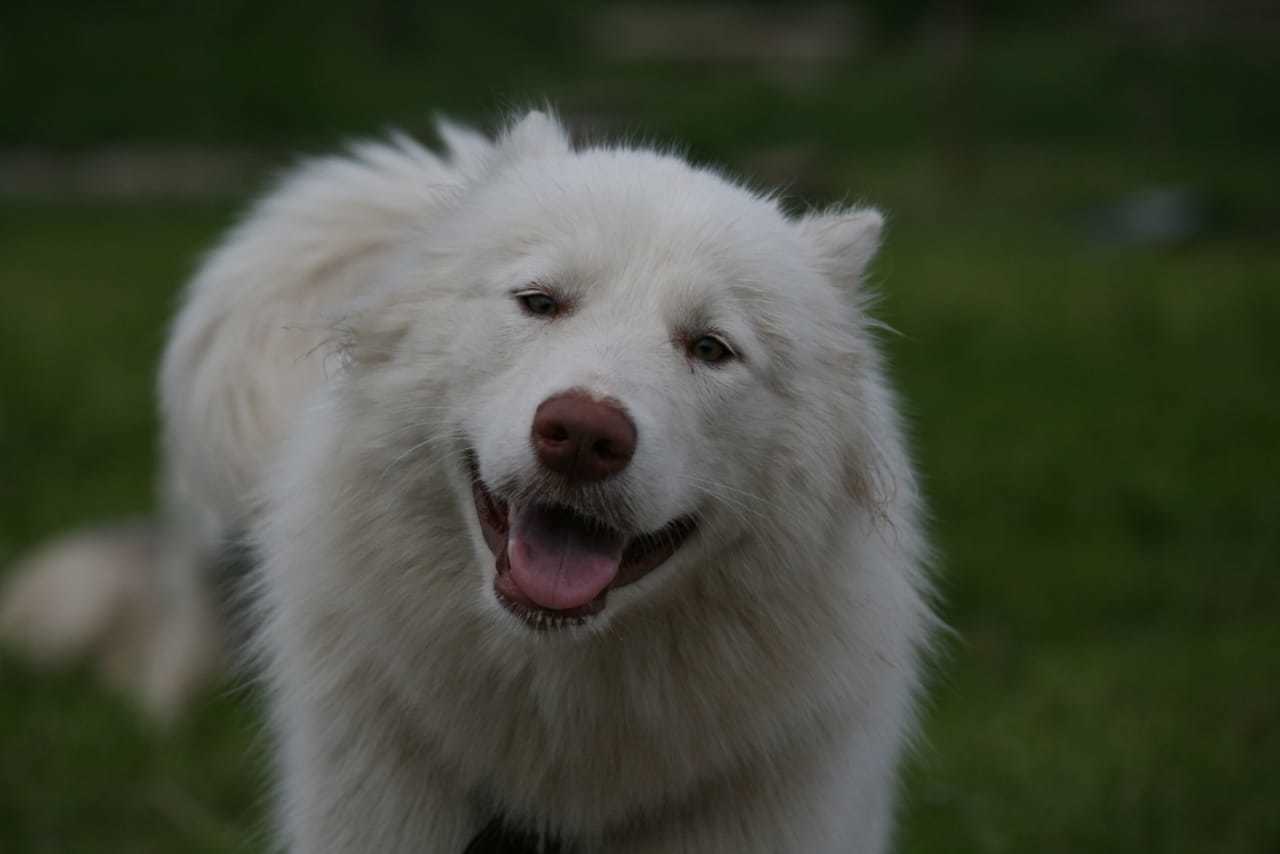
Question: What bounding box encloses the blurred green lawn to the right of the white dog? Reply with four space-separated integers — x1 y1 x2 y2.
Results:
884 195 1280 851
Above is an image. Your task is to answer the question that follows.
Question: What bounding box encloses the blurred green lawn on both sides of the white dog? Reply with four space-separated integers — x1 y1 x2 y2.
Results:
0 150 1280 851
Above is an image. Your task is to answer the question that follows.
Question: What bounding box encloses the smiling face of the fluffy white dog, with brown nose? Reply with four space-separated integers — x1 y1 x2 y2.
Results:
358 113 879 629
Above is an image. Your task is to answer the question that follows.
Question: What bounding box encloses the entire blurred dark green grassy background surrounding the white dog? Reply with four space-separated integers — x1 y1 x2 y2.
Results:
0 0 1280 854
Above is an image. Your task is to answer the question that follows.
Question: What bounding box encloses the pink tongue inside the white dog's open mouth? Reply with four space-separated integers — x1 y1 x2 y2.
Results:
507 504 623 611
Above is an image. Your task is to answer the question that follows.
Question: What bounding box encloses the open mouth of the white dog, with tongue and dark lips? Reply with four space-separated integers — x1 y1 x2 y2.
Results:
467 455 696 629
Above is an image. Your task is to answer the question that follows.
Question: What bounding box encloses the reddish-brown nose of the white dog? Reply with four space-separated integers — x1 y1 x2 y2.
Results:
532 392 636 481
